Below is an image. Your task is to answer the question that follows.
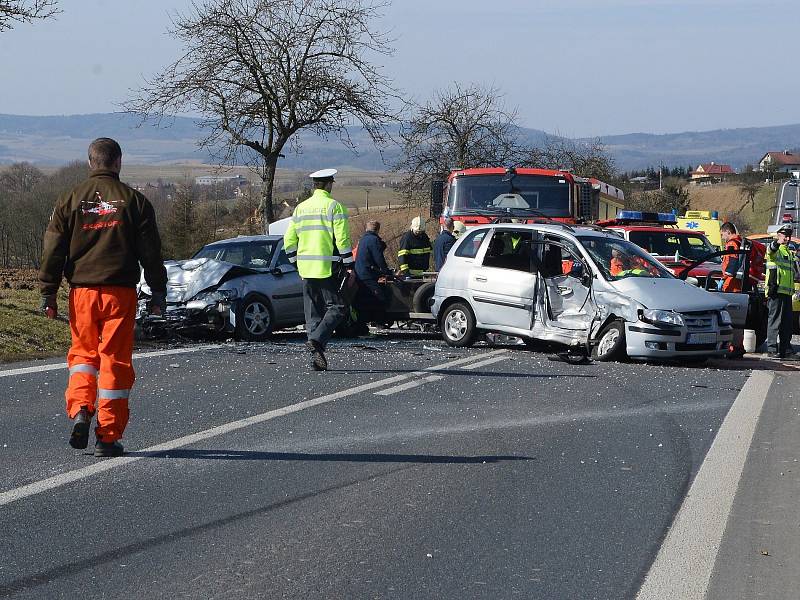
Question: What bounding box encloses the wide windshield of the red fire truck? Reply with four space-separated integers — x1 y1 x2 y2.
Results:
447 174 570 217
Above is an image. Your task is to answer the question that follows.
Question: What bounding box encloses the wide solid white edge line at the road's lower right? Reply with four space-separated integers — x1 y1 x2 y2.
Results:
636 371 774 600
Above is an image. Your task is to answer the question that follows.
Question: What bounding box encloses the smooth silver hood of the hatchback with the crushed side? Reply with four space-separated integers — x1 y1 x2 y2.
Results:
611 277 728 312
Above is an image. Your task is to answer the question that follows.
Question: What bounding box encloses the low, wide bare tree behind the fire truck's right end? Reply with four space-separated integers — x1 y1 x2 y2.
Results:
525 135 616 181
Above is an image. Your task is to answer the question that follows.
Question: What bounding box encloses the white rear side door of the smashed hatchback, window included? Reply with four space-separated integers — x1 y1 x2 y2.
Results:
469 229 537 329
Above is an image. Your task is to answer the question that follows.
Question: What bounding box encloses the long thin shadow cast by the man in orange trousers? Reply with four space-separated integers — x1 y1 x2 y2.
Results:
126 448 534 465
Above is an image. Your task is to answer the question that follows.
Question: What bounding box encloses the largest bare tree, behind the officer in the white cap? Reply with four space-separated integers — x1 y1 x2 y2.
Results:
124 0 397 229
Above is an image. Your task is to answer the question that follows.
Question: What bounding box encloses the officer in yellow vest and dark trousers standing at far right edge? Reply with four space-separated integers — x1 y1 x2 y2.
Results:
764 225 795 358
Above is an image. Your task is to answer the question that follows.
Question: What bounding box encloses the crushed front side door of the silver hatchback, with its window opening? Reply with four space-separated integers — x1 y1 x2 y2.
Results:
539 235 595 330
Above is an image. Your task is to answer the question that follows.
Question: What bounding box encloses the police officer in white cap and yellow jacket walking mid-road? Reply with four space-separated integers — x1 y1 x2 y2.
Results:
283 169 353 371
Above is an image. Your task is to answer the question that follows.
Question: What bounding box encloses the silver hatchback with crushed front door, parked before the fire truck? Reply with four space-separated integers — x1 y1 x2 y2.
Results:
432 222 736 360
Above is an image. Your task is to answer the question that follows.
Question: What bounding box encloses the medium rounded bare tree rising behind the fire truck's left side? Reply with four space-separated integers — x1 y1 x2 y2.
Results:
393 83 525 196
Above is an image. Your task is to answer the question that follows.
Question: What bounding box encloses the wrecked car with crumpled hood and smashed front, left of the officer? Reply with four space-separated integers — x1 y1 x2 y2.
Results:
137 235 304 341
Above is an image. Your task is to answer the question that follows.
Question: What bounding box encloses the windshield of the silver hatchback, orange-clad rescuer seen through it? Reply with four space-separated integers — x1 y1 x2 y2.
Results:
578 236 674 281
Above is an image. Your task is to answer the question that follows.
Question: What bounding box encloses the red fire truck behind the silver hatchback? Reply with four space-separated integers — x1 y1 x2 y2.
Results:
431 167 625 227
